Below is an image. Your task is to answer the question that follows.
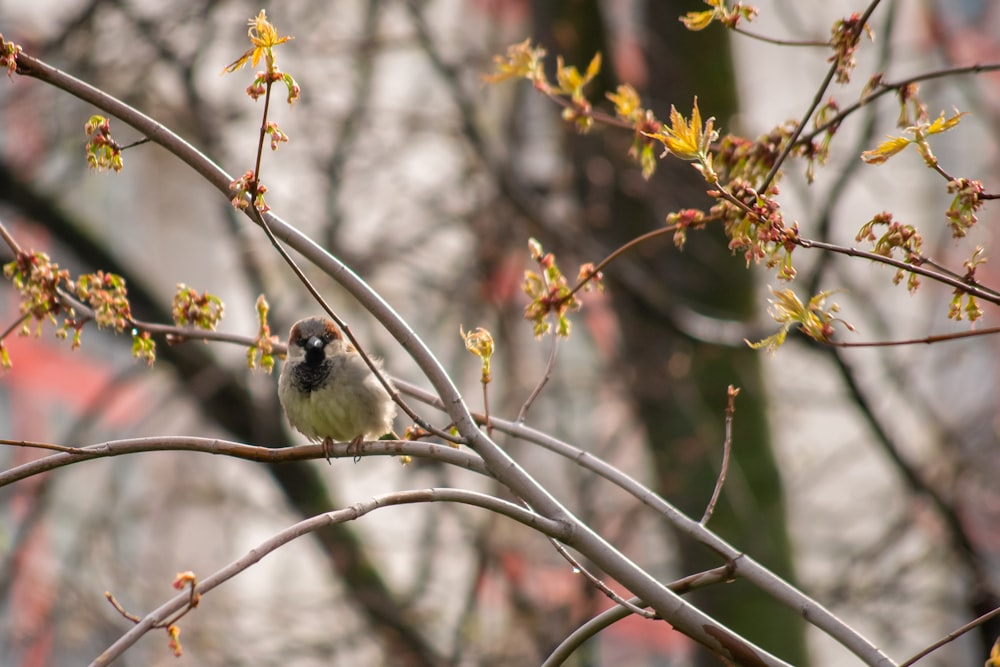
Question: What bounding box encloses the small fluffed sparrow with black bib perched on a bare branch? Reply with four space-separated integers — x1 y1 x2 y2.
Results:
278 317 396 460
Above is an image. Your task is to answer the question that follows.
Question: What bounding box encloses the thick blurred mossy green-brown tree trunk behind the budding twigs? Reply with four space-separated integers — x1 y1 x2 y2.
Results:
535 0 807 665
